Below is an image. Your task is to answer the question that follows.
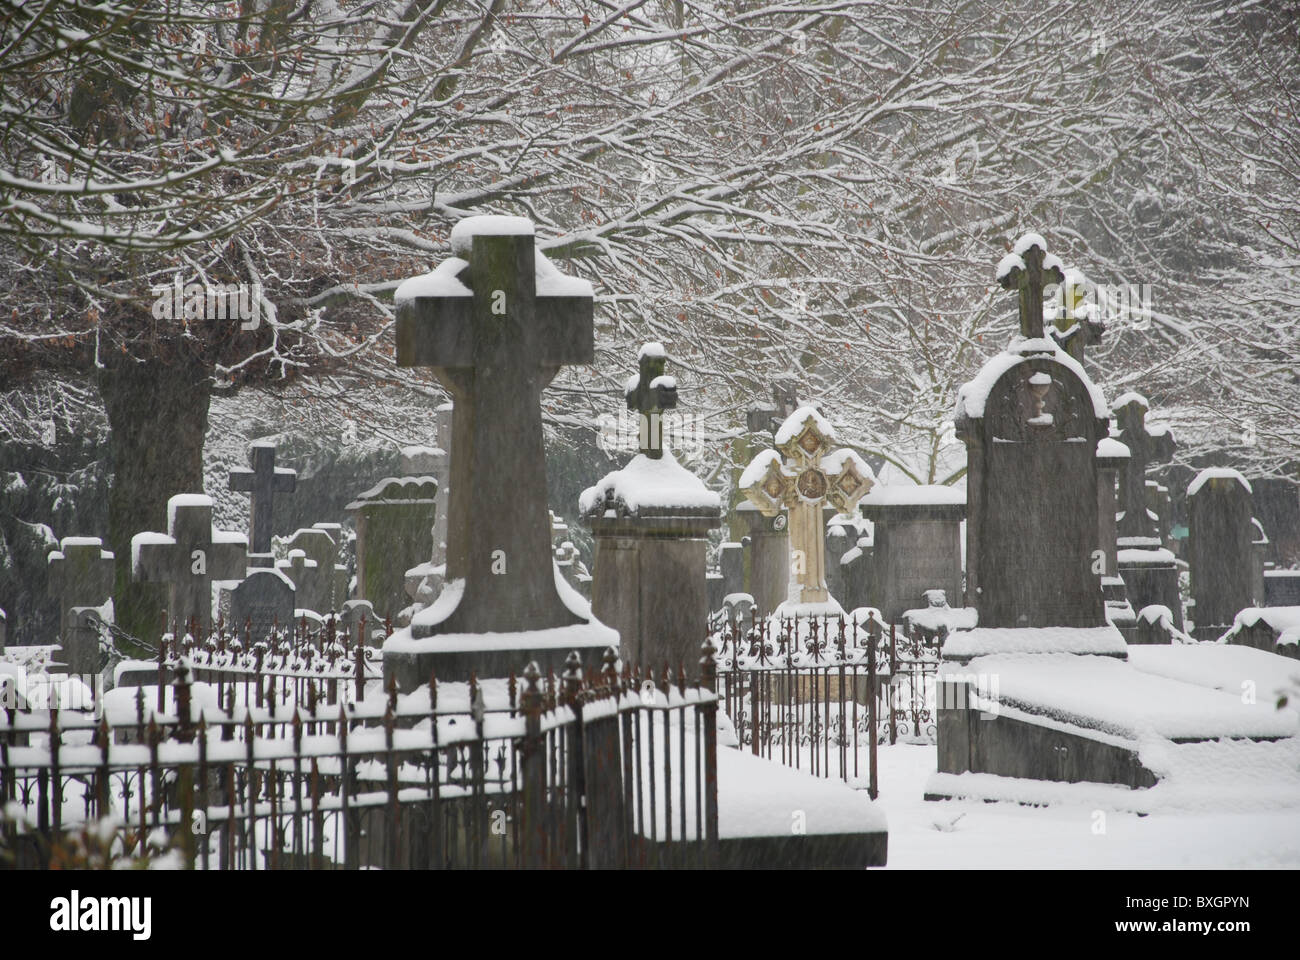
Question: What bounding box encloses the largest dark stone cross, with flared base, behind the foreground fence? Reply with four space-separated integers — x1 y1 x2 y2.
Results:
395 217 594 637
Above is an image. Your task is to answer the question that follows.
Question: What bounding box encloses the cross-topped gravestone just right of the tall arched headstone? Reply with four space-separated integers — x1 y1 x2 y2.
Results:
1112 393 1183 630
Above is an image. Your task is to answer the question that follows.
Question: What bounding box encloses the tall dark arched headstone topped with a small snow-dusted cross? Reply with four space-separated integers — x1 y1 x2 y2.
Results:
956 234 1109 628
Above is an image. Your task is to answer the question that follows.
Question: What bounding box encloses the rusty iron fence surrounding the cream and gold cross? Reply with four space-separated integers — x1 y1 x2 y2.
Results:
711 617 940 799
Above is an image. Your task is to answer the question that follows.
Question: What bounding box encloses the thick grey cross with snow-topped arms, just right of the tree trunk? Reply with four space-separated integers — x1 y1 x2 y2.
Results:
131 493 248 628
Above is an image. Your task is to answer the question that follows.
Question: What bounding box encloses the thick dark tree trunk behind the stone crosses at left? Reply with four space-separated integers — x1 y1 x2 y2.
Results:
99 351 212 643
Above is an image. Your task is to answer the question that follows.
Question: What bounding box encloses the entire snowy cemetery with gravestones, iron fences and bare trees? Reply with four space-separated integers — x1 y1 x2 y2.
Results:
0 3 1300 873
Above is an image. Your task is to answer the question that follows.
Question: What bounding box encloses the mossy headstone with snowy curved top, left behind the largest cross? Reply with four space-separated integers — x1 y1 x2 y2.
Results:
347 476 437 617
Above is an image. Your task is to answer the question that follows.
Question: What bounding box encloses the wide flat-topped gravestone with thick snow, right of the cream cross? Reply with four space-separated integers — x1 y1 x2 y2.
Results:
861 484 966 623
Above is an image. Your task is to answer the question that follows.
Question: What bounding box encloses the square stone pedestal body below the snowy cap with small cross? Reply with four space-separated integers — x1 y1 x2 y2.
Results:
589 516 722 670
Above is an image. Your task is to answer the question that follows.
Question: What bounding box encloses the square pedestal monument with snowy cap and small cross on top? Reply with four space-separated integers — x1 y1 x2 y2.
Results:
579 343 722 666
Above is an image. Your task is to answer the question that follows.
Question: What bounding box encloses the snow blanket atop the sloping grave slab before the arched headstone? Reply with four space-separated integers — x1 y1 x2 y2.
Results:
940 644 1300 740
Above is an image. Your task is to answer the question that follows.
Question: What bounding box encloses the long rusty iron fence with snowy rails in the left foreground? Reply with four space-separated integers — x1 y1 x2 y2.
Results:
0 645 719 870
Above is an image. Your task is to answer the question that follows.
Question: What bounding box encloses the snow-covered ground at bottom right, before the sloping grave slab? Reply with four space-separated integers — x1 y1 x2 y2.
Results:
878 744 1300 869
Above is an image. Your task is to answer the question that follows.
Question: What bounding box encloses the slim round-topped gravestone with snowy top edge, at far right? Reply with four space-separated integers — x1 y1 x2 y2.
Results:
1187 468 1253 640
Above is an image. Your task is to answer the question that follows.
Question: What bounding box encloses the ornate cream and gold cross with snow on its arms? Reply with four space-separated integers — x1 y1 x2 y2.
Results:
741 407 874 604
